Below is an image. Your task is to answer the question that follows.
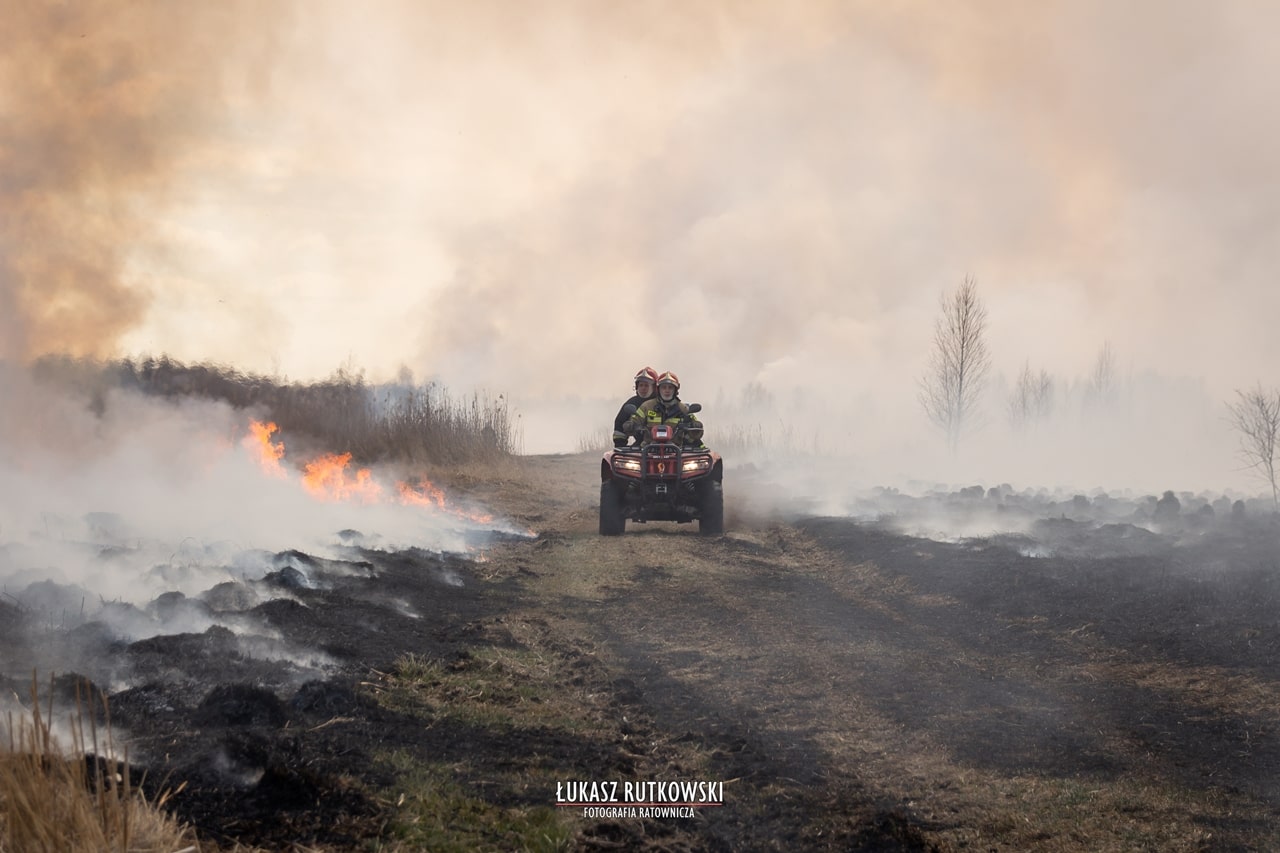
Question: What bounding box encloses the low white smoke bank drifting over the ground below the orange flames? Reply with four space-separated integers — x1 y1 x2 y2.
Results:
0 369 506 630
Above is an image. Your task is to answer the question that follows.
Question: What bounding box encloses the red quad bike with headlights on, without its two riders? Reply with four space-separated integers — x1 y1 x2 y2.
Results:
600 403 724 537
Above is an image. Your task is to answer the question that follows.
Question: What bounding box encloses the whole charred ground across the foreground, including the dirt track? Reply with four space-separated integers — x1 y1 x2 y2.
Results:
0 455 1280 850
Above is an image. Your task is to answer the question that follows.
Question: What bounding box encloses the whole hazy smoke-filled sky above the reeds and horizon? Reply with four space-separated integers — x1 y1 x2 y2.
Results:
0 0 1280 484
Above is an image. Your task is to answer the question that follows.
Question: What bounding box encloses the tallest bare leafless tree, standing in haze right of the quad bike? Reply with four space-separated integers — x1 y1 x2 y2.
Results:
920 277 991 451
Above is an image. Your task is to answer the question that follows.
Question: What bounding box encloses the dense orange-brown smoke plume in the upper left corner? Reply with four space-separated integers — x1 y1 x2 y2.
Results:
0 0 288 359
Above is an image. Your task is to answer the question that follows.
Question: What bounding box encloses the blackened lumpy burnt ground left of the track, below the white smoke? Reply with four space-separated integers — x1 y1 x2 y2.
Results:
0 532 524 848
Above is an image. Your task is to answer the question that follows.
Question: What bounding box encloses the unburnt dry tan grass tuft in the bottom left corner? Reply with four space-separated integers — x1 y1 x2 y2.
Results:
0 680 198 853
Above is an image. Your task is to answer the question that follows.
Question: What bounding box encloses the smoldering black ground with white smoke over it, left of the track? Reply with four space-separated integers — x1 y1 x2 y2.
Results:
0 364 527 844
